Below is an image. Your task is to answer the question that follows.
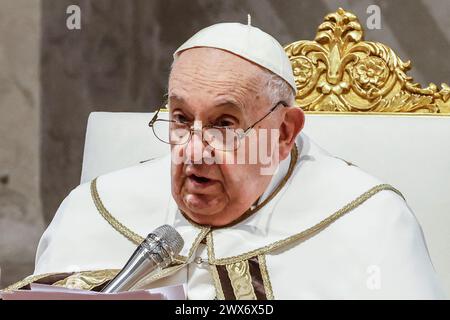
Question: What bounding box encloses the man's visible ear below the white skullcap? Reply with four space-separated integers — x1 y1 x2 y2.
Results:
279 107 305 160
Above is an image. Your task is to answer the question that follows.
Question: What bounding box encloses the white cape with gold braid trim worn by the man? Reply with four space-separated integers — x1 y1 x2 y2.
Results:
8 134 444 299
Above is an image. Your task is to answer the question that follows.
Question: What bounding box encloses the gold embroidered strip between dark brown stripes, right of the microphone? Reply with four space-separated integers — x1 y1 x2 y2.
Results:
226 260 257 300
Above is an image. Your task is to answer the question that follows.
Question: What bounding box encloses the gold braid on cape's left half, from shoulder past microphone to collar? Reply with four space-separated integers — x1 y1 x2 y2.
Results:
91 178 210 264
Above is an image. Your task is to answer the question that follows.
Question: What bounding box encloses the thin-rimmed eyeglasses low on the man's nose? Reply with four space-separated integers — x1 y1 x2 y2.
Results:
148 101 288 151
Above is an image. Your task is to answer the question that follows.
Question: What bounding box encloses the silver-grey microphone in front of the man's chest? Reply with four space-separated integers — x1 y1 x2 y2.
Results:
101 224 184 293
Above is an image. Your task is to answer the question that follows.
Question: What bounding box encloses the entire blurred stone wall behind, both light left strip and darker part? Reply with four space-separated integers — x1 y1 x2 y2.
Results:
0 0 450 287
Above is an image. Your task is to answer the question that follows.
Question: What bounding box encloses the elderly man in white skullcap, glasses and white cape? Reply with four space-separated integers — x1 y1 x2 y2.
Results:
4 23 443 299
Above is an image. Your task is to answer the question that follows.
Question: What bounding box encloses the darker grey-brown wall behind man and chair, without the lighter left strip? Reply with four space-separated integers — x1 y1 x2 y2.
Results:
41 0 450 229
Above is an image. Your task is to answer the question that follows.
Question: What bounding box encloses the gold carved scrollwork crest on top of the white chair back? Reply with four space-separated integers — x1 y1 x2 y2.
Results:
285 9 450 114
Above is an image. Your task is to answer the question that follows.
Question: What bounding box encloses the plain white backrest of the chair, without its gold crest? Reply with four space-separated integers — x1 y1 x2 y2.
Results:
81 112 450 293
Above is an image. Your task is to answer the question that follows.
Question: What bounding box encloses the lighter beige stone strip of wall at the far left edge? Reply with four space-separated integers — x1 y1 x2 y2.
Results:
0 0 44 288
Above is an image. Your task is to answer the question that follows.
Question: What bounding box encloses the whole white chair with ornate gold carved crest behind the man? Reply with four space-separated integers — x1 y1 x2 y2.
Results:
81 9 450 294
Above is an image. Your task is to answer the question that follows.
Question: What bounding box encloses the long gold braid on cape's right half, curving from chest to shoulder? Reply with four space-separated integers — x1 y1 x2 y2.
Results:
207 184 404 265
